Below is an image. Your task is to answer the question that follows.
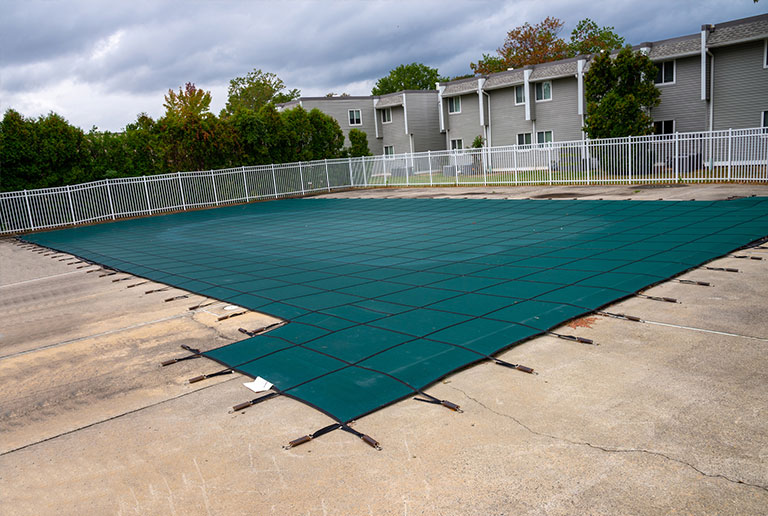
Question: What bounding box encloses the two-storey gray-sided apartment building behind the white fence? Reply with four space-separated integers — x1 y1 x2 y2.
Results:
281 14 768 154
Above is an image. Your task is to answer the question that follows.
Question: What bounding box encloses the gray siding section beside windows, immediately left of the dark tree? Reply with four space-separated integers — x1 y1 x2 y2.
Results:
532 77 581 142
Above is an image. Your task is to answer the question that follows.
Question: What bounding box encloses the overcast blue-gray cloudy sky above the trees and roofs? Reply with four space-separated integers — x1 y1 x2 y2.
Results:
0 0 768 131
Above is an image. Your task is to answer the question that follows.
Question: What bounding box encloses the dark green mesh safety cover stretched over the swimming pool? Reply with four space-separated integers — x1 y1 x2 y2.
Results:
24 198 768 422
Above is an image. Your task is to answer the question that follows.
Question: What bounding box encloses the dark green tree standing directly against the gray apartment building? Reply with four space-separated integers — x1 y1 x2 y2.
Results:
584 46 661 138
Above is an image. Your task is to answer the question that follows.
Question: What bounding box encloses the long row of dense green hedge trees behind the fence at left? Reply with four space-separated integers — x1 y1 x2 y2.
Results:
0 73 345 191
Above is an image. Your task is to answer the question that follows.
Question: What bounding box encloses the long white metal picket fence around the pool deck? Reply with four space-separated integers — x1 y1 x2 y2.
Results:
0 128 768 234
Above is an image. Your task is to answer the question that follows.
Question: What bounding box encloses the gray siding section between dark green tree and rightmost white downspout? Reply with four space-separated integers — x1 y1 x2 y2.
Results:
651 56 708 132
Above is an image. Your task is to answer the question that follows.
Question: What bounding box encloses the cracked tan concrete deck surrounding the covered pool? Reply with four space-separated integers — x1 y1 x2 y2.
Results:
0 185 768 515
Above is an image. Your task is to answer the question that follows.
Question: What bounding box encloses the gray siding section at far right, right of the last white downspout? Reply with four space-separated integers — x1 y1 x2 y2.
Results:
702 40 768 130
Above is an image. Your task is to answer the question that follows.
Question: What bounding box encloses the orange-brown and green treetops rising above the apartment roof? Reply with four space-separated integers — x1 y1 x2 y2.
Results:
469 16 624 75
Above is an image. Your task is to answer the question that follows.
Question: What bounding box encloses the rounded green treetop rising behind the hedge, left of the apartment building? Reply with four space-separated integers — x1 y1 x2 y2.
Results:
221 69 301 116
